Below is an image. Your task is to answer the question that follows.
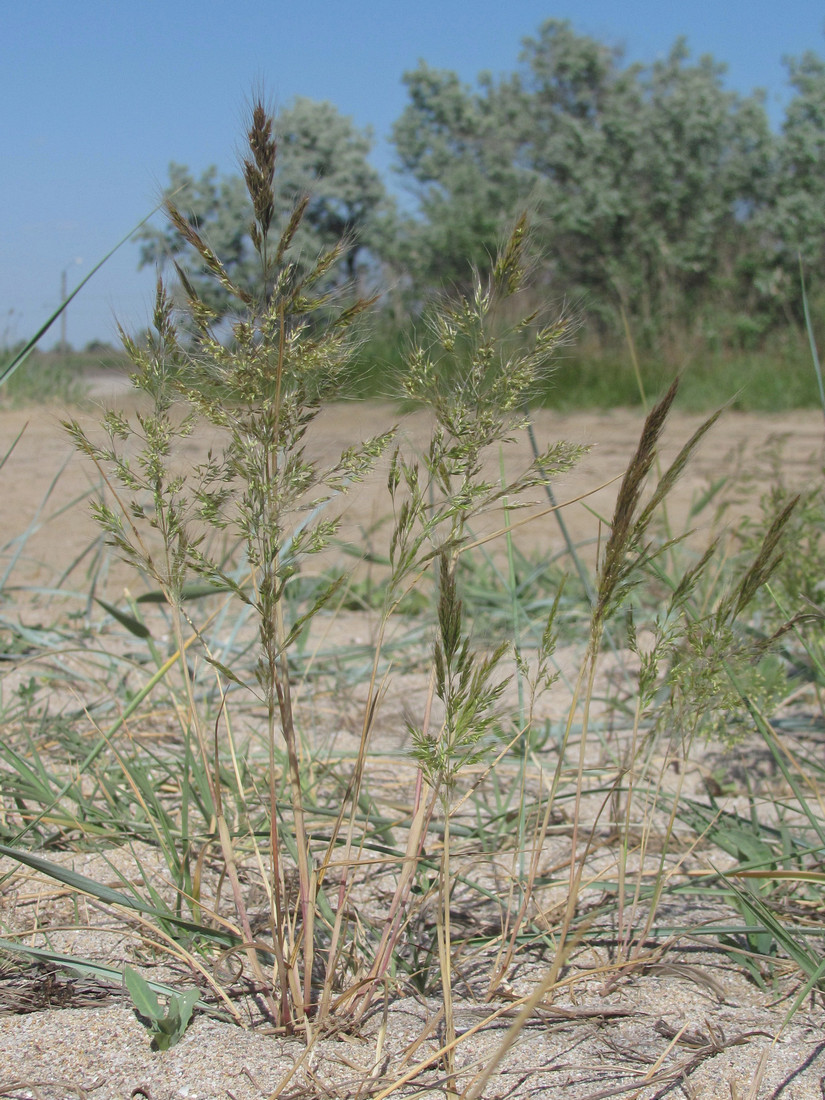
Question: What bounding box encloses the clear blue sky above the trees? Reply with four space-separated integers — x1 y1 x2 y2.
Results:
0 0 825 347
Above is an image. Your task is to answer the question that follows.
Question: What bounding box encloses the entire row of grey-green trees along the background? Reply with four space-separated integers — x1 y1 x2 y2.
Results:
142 21 825 365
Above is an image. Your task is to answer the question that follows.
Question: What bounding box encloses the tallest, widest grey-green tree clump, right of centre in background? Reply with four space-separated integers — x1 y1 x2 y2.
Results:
394 20 773 338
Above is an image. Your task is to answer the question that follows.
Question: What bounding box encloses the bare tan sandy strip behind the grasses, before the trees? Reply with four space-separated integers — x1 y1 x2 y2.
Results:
0 381 825 596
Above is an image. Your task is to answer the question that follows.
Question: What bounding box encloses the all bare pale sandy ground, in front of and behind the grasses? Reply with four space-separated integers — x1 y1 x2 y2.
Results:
0 380 825 1100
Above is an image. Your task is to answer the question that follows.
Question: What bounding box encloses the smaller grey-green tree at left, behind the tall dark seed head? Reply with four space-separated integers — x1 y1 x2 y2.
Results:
141 98 393 316
